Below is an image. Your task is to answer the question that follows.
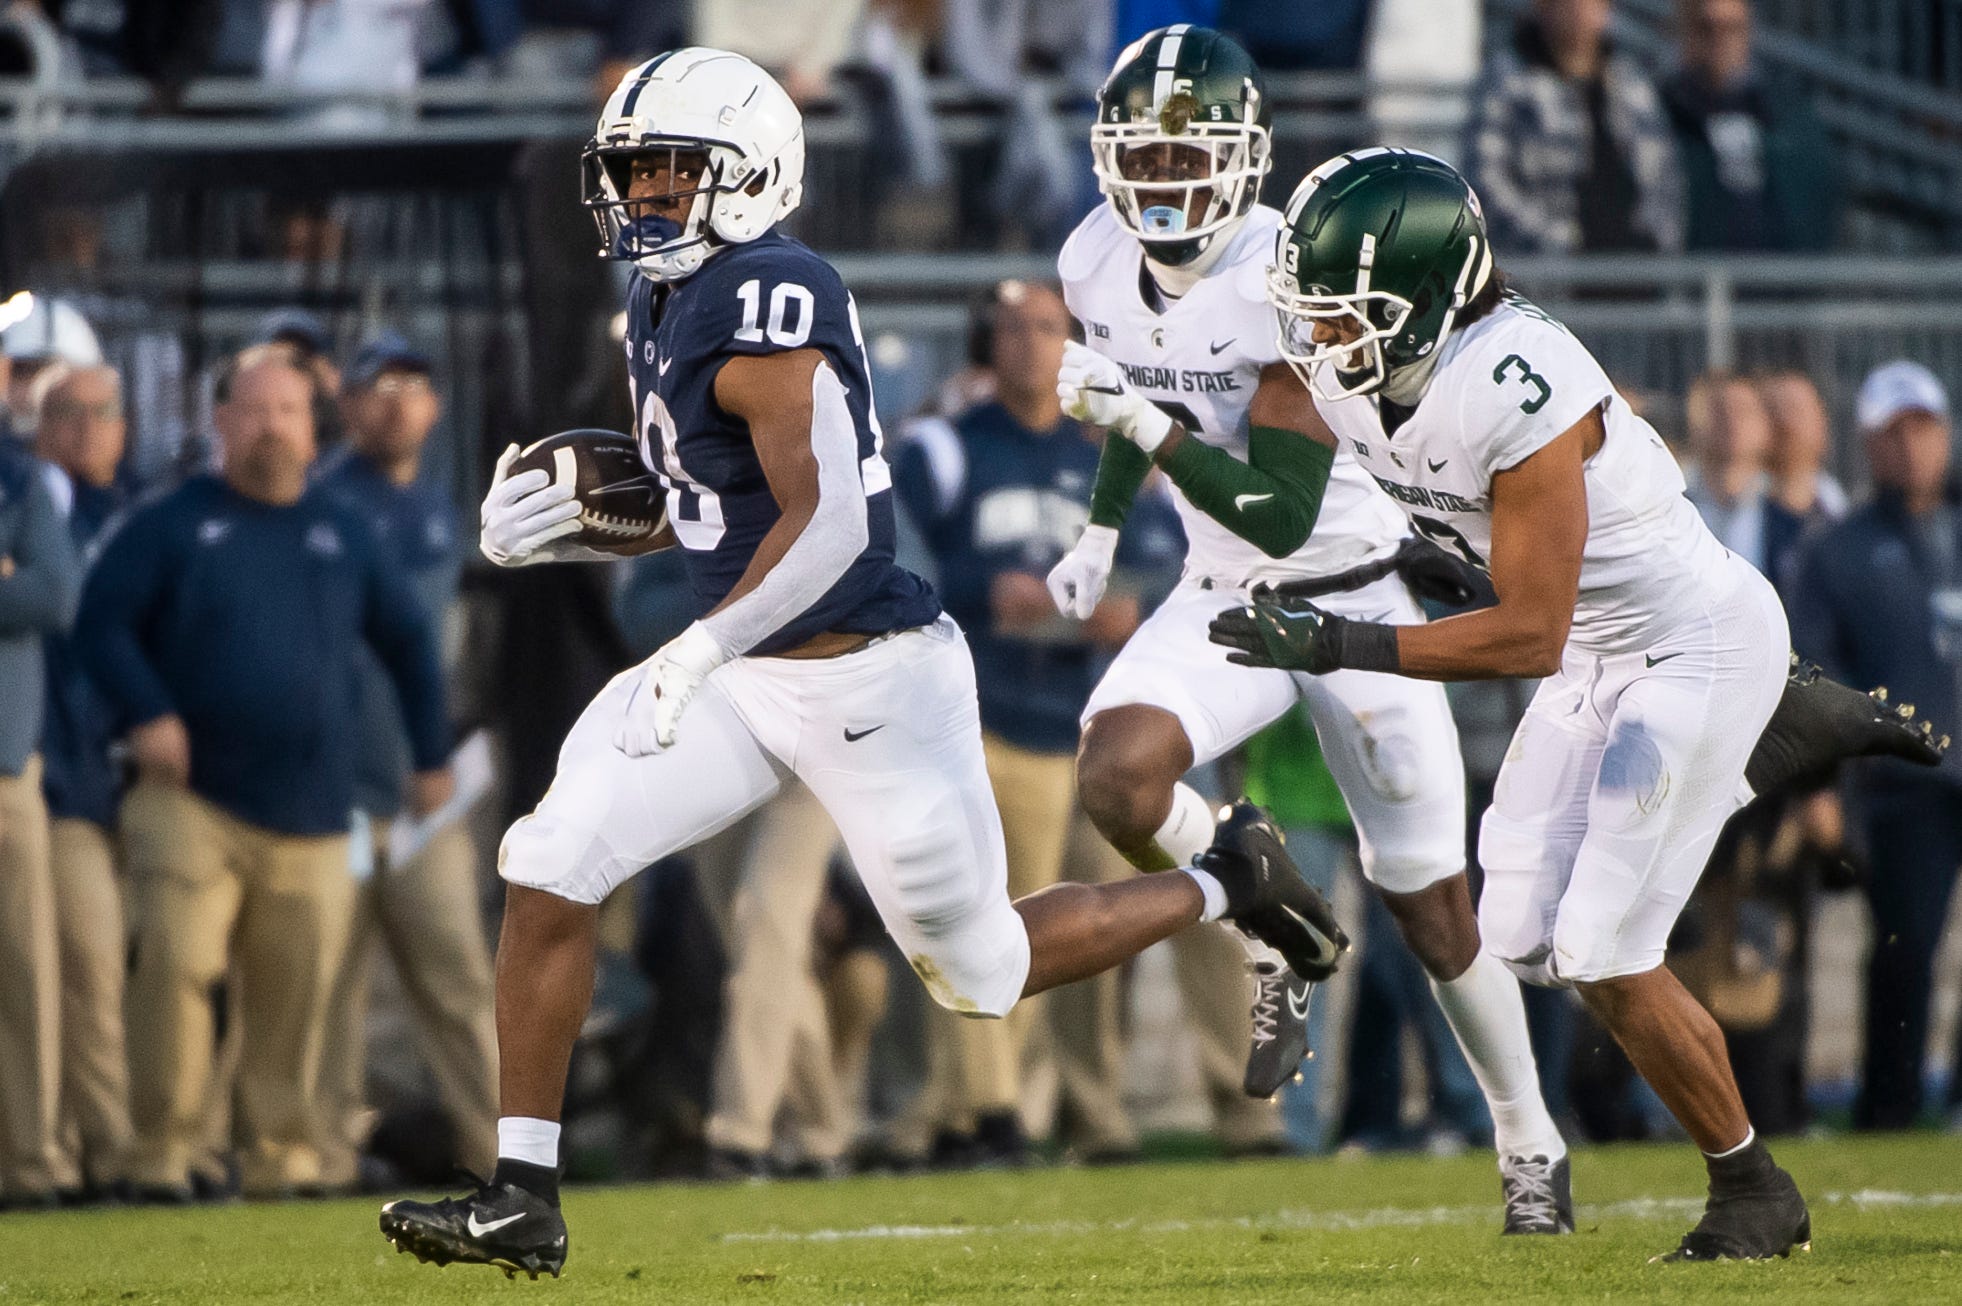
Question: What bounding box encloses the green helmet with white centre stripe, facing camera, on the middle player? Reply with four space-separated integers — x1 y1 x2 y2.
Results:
1091 24 1273 267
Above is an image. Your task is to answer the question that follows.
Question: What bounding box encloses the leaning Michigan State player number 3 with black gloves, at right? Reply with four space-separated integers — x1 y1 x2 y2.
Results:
1213 149 1938 1261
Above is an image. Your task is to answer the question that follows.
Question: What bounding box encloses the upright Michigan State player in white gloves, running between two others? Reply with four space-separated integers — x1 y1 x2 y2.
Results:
1050 25 1574 1233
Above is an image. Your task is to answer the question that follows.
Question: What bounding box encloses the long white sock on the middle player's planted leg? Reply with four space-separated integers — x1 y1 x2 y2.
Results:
1430 951 1568 1161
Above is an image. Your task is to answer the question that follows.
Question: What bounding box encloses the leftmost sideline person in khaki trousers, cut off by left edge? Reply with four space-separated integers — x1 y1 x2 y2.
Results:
0 392 80 1206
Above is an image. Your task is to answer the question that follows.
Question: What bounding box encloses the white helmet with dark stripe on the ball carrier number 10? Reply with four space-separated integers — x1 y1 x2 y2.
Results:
581 47 804 280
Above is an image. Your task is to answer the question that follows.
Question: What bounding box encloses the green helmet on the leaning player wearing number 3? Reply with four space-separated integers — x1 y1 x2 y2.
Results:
1267 147 1491 400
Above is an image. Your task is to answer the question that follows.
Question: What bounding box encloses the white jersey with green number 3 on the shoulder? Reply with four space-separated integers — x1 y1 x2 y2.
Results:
1317 298 1734 655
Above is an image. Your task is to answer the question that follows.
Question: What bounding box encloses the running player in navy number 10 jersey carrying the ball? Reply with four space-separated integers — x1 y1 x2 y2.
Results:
381 49 1342 1277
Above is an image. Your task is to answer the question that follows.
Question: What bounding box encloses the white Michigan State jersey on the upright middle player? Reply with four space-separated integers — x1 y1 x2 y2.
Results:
1056 204 1405 584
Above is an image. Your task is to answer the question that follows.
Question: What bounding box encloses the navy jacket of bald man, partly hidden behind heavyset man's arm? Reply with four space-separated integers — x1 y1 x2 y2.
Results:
41 482 124 828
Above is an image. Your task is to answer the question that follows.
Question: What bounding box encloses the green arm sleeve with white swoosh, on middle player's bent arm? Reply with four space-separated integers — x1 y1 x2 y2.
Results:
1153 426 1336 557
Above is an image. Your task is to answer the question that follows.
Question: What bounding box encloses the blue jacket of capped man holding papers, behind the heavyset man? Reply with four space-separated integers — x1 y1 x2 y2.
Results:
320 451 463 816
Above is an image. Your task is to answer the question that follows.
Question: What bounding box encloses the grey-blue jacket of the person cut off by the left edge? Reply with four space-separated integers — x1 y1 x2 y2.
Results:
0 443 82 775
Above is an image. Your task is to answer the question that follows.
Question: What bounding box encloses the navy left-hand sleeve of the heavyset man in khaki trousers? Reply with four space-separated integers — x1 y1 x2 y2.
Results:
75 502 177 726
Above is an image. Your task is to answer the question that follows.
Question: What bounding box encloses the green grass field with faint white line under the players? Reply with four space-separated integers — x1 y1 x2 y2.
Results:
0 1133 1962 1306
